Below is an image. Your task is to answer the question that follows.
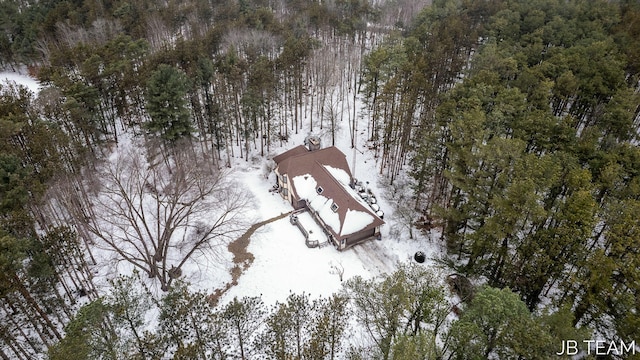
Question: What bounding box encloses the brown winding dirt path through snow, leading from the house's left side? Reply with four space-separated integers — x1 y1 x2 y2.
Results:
209 211 293 305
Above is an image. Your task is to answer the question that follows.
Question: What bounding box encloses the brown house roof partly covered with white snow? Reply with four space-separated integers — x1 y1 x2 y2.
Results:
274 146 384 240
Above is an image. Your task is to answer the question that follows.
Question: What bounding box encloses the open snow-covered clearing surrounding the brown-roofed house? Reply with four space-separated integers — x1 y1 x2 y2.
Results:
210 105 440 304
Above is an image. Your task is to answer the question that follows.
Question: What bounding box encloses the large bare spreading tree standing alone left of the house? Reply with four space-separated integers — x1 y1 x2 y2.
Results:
82 143 248 291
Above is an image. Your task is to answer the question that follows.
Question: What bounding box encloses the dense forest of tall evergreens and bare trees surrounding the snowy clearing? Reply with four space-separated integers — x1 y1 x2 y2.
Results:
0 0 640 359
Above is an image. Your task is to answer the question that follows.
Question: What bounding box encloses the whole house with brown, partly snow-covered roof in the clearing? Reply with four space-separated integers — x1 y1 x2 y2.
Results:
273 146 384 250
